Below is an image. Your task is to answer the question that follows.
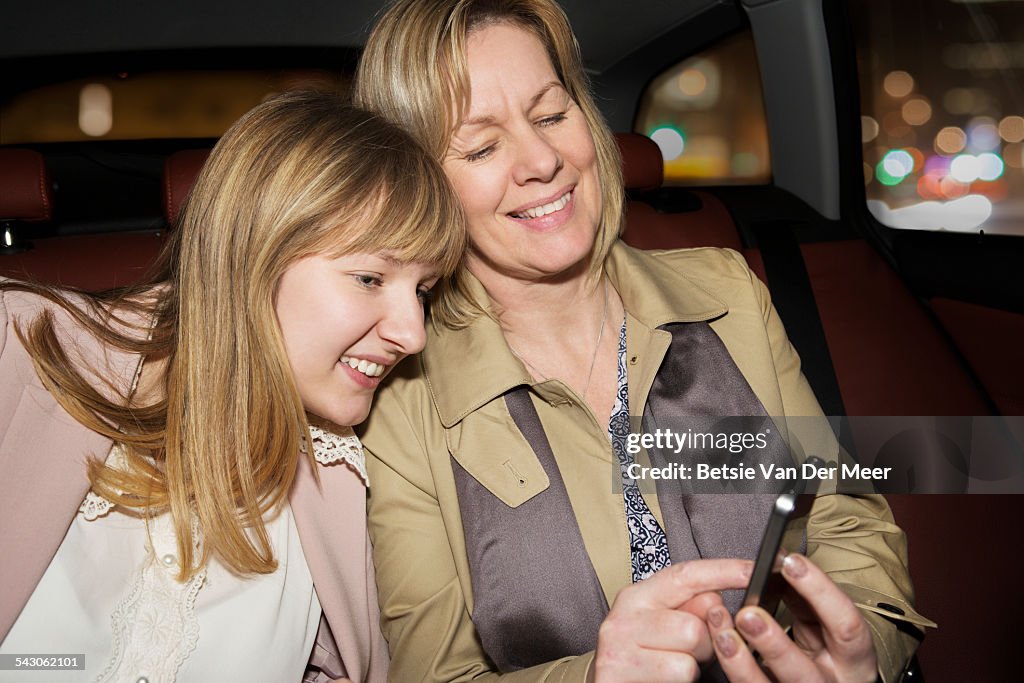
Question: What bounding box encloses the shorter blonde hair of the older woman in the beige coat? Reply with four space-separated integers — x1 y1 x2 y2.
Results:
353 0 624 328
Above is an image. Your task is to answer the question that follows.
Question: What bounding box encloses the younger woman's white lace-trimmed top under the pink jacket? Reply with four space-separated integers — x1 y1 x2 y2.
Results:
0 427 367 683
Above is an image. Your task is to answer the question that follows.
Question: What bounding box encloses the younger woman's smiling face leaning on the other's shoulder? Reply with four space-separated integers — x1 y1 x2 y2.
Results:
274 254 437 425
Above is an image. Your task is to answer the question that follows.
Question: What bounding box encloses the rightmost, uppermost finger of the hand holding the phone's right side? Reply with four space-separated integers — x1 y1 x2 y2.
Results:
782 554 876 676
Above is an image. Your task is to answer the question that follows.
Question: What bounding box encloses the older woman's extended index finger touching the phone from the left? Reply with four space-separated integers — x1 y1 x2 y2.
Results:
613 559 754 609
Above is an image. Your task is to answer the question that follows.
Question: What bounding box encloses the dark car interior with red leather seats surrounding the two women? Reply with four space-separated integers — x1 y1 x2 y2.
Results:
0 0 1024 681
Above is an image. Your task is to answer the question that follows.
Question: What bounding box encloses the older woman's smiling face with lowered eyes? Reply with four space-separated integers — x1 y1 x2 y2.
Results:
444 23 601 286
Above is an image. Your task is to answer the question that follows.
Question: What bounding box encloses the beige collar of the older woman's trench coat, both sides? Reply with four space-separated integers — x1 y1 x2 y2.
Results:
421 242 728 428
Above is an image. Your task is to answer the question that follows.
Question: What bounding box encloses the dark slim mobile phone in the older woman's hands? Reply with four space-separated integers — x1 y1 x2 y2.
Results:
743 457 824 614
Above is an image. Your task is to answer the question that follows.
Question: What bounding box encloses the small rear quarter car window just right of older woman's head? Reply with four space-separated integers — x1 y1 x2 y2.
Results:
634 31 771 185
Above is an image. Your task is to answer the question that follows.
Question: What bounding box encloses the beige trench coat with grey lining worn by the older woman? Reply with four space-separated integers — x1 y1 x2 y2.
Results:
364 244 930 682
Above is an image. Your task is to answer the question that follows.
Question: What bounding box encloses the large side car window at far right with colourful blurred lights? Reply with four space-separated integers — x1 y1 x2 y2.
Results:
848 0 1024 234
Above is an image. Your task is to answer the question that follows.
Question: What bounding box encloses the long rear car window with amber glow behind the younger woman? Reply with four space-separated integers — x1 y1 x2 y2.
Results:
0 70 349 144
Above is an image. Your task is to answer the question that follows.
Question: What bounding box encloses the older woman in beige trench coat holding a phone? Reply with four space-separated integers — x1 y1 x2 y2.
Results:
356 0 924 683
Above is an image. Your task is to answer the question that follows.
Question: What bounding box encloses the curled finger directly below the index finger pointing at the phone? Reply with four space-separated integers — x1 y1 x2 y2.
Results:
598 609 714 661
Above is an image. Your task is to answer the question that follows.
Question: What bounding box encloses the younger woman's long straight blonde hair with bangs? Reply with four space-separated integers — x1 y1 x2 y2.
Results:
3 92 465 580
